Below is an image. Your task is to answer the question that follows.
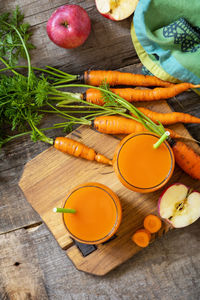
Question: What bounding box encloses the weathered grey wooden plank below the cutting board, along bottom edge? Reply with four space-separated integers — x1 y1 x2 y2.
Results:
0 221 200 300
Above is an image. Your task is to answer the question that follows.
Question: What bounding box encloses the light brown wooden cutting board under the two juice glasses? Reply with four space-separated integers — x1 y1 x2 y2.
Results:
19 101 200 275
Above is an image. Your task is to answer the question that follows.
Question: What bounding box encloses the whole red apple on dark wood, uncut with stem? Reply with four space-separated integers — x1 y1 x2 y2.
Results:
47 5 91 49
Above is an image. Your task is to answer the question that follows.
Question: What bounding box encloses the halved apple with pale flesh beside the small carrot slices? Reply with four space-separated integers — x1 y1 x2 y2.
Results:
158 183 200 228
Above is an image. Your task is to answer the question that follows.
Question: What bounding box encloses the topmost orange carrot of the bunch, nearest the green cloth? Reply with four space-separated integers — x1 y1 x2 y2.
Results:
84 70 173 87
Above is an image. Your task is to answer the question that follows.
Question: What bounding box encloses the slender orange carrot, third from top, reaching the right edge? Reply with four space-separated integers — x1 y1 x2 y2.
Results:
138 107 200 125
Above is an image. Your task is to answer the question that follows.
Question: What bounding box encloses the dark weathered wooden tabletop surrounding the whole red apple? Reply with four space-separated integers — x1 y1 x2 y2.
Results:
0 0 139 74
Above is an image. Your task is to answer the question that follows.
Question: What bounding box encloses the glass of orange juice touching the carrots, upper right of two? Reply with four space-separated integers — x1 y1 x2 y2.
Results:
113 132 175 193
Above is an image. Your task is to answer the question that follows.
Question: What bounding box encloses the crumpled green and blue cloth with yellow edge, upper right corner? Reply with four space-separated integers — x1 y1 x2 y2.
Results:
131 0 200 84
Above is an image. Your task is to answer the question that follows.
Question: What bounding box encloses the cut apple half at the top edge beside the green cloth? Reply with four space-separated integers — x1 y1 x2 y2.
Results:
96 0 139 21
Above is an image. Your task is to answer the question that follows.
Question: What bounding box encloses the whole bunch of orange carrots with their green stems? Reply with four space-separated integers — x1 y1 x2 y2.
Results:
1 61 200 179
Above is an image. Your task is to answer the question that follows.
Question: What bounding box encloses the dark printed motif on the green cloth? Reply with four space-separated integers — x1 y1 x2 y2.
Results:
163 18 200 53
